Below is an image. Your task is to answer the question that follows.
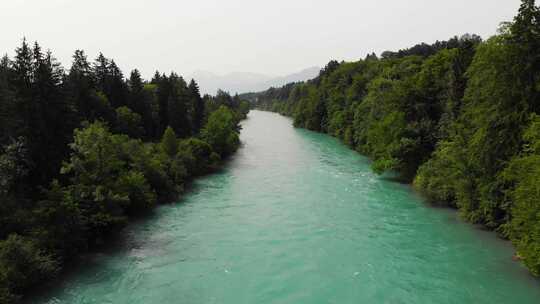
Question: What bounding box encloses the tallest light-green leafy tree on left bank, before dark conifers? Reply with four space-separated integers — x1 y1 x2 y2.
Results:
62 122 134 241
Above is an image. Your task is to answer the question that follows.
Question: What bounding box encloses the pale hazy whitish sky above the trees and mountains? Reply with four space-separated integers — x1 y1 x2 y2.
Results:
0 0 520 77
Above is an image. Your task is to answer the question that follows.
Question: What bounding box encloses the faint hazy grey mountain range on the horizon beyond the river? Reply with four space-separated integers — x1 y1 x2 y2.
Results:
189 67 320 94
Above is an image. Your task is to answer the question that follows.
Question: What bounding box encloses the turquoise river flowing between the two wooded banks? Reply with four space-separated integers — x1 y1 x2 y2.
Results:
35 111 540 304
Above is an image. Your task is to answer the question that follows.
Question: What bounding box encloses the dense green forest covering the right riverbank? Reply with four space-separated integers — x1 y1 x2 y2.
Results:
246 0 540 275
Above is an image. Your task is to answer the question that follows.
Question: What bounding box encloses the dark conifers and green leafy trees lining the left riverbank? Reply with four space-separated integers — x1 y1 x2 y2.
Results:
0 40 248 303
